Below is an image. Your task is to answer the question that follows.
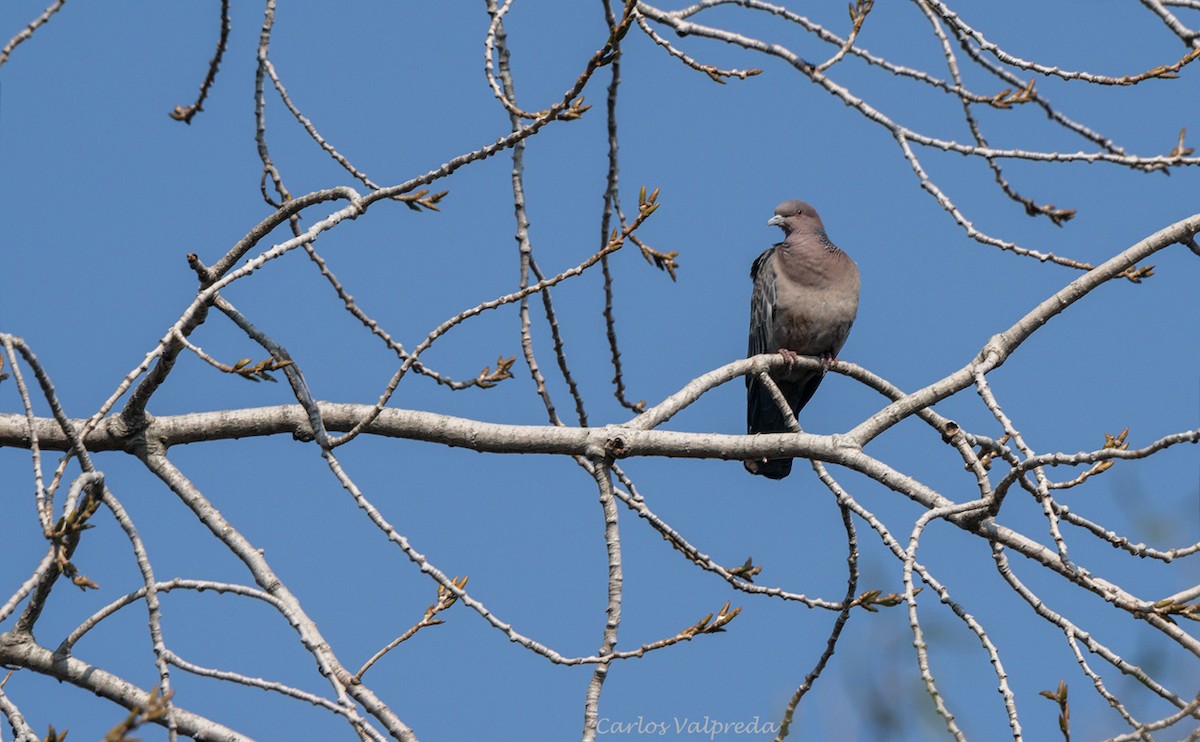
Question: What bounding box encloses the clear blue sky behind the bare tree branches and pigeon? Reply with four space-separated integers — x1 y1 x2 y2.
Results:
0 0 1200 740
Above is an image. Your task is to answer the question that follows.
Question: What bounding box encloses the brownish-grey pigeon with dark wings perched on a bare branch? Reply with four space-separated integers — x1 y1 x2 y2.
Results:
743 201 859 479
